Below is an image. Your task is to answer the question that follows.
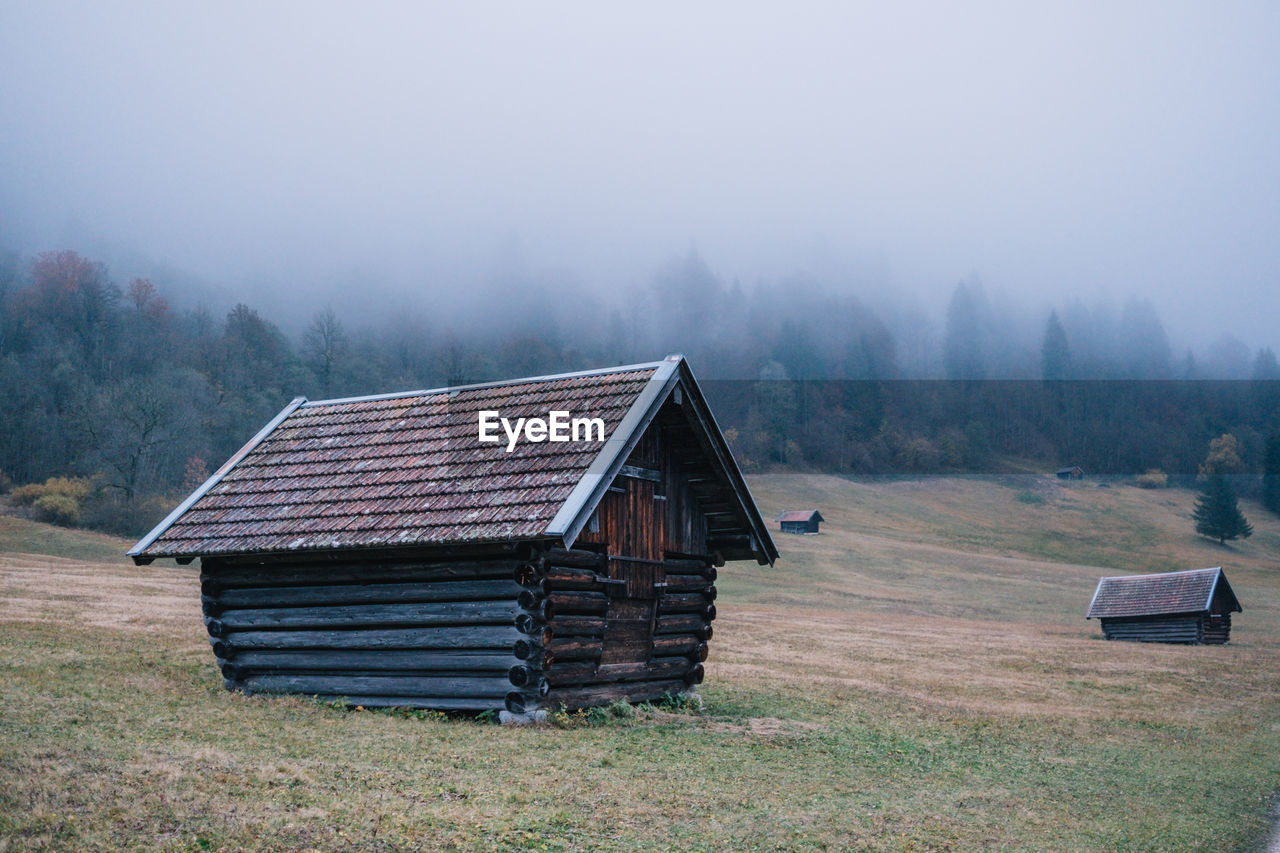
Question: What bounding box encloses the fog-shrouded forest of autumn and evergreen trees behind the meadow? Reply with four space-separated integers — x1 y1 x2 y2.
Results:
0 245 1280 533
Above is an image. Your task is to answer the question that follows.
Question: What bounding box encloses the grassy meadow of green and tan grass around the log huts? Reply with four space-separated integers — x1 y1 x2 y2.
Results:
0 475 1280 850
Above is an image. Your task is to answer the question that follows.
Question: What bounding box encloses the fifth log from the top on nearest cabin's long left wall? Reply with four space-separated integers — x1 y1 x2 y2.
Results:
221 646 517 675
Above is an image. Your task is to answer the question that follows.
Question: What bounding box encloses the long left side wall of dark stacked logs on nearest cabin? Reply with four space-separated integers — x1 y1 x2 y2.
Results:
201 556 529 711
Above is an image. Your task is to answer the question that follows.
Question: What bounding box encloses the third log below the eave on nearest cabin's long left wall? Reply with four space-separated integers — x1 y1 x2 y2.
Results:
220 601 516 630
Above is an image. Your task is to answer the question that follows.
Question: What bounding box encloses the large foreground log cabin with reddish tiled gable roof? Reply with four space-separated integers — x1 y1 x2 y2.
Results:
129 356 778 715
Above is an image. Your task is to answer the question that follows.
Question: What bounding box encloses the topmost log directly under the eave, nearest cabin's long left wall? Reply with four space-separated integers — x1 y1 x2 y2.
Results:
200 557 517 594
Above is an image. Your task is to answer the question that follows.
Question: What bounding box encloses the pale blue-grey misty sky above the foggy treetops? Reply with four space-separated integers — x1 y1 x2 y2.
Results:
0 0 1280 346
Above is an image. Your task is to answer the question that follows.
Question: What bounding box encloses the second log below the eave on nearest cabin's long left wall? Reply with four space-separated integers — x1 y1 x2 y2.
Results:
209 579 520 610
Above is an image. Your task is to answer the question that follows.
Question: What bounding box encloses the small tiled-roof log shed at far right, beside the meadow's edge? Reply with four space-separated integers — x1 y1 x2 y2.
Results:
1085 567 1242 643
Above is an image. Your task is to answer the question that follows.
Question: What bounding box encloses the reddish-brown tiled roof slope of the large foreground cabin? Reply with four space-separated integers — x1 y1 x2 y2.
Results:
131 365 657 558
